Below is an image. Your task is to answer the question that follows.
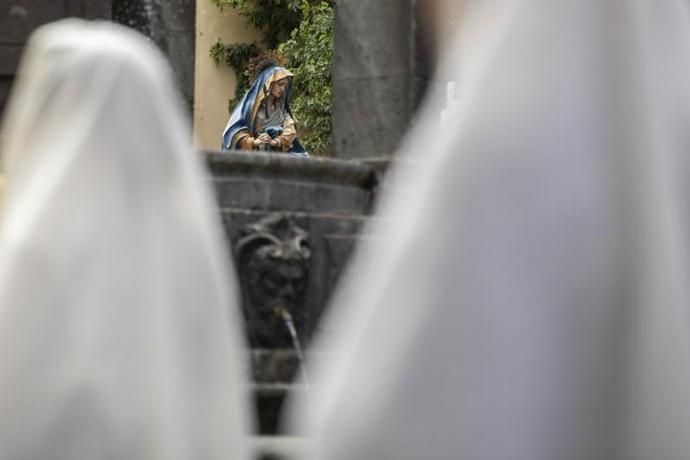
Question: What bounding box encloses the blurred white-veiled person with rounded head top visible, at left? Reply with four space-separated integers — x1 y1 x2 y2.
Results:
0 21 248 460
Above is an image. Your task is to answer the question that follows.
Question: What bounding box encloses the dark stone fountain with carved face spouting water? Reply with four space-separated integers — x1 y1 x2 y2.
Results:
207 152 378 451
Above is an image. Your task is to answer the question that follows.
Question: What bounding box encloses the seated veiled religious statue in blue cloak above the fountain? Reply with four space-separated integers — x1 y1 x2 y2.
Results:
222 54 309 157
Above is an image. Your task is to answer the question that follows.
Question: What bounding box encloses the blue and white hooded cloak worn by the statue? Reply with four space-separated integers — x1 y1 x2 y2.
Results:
222 66 309 157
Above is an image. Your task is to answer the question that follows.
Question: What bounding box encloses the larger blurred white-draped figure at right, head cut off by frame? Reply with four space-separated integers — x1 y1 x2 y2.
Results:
296 0 690 460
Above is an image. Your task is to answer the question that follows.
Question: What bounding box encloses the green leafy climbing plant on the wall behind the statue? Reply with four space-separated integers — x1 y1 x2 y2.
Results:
210 0 334 156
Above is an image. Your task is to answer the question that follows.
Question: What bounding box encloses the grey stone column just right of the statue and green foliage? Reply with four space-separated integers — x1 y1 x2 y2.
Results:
333 0 428 160
